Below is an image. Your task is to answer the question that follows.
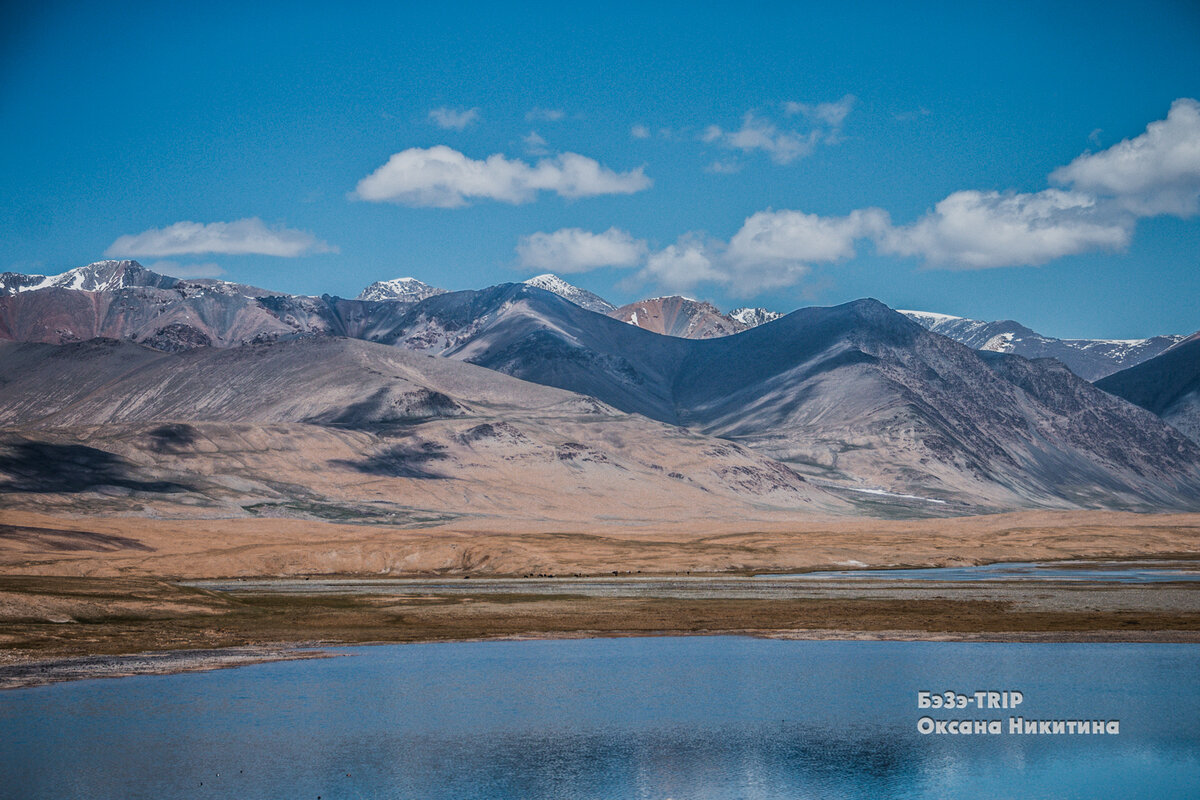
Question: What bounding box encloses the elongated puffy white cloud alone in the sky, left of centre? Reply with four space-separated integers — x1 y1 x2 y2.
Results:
354 145 652 209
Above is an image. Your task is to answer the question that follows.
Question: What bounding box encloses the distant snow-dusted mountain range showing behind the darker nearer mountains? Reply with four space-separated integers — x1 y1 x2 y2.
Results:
0 260 1184 380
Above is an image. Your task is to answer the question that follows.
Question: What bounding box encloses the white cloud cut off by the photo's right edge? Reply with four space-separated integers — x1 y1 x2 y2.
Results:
1050 97 1200 217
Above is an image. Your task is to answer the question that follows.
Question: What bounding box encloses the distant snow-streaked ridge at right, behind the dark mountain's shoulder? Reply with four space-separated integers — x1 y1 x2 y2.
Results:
900 309 1184 380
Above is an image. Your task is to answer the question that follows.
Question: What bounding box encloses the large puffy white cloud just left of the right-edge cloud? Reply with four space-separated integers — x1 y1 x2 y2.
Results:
877 190 1133 269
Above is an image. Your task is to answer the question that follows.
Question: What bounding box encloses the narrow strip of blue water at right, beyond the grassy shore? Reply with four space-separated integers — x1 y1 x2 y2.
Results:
758 561 1200 583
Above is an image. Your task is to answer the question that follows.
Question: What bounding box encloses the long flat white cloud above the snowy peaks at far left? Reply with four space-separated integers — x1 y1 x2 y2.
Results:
104 217 337 258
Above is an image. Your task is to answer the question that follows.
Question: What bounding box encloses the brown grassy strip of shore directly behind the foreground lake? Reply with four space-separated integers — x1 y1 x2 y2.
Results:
0 553 1200 688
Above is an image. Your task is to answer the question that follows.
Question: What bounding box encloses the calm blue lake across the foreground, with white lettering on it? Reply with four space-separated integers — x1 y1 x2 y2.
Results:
0 637 1200 800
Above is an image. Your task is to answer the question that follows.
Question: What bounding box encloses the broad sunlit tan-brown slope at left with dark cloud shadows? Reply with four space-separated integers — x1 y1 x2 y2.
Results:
0 338 852 525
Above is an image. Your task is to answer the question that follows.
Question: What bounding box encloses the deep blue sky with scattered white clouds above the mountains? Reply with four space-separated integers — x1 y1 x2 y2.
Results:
0 1 1200 337
